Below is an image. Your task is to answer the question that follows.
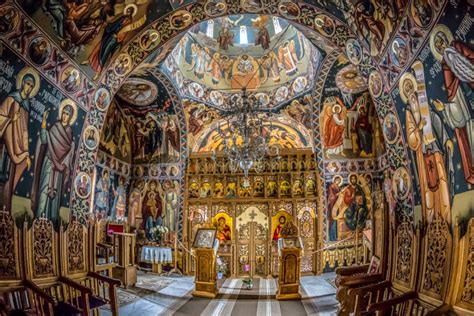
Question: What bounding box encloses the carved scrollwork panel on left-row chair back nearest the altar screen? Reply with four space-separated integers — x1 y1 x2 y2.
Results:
66 221 86 273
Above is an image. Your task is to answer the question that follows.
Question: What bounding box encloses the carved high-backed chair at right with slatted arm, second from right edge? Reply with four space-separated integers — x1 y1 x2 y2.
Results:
348 216 452 315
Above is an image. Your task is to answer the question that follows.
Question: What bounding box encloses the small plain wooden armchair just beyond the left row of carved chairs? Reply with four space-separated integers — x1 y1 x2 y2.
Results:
88 219 116 277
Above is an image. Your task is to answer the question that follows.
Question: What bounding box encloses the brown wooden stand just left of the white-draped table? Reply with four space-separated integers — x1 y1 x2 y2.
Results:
112 233 137 287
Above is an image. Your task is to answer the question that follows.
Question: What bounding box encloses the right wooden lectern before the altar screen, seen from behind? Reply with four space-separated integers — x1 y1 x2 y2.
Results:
276 237 303 300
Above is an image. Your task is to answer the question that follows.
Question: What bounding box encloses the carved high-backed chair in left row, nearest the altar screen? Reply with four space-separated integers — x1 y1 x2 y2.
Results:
60 220 120 315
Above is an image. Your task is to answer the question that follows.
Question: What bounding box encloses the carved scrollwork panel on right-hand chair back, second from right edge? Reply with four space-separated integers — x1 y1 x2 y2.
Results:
423 217 449 294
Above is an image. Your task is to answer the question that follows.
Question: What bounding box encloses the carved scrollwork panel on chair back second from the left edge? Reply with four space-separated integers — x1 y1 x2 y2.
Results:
32 218 54 277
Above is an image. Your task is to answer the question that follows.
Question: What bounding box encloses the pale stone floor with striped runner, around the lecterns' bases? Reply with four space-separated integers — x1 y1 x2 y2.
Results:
101 273 338 316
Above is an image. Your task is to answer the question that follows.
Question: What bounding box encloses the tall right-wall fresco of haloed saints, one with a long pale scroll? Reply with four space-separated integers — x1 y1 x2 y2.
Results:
384 3 474 223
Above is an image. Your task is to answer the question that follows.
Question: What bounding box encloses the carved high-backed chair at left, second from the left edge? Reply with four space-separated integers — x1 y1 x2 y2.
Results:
23 218 85 315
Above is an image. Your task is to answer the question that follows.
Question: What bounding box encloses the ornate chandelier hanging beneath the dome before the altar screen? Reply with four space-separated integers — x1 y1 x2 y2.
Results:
213 89 278 177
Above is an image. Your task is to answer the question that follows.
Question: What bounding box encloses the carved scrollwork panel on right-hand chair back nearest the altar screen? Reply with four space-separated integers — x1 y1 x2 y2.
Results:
395 222 413 283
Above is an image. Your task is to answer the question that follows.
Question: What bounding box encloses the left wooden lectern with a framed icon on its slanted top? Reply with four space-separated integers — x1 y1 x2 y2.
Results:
192 228 219 298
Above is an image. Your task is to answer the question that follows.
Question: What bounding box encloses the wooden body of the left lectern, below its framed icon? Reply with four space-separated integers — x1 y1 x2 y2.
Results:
192 248 217 298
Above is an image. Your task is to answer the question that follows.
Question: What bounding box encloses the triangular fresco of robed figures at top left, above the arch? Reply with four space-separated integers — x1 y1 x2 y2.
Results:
16 0 180 79
